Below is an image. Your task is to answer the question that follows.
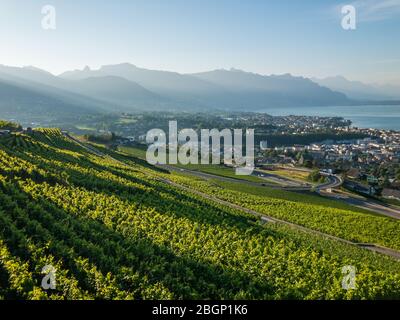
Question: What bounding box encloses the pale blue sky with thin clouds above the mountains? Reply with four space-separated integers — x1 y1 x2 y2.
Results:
0 0 400 85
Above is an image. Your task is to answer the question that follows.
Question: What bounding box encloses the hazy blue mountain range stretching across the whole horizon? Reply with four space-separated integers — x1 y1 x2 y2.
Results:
0 63 396 119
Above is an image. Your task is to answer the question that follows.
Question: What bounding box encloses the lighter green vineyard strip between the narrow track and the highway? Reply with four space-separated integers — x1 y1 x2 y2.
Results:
169 175 400 250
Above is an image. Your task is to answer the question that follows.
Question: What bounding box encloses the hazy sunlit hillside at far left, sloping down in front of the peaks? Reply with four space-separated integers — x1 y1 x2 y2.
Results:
0 65 109 121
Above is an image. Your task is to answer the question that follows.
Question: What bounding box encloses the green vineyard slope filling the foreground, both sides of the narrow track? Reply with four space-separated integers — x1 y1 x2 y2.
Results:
0 129 400 299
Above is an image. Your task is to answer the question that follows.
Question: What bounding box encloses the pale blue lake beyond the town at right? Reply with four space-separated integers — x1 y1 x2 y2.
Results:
262 105 400 131
